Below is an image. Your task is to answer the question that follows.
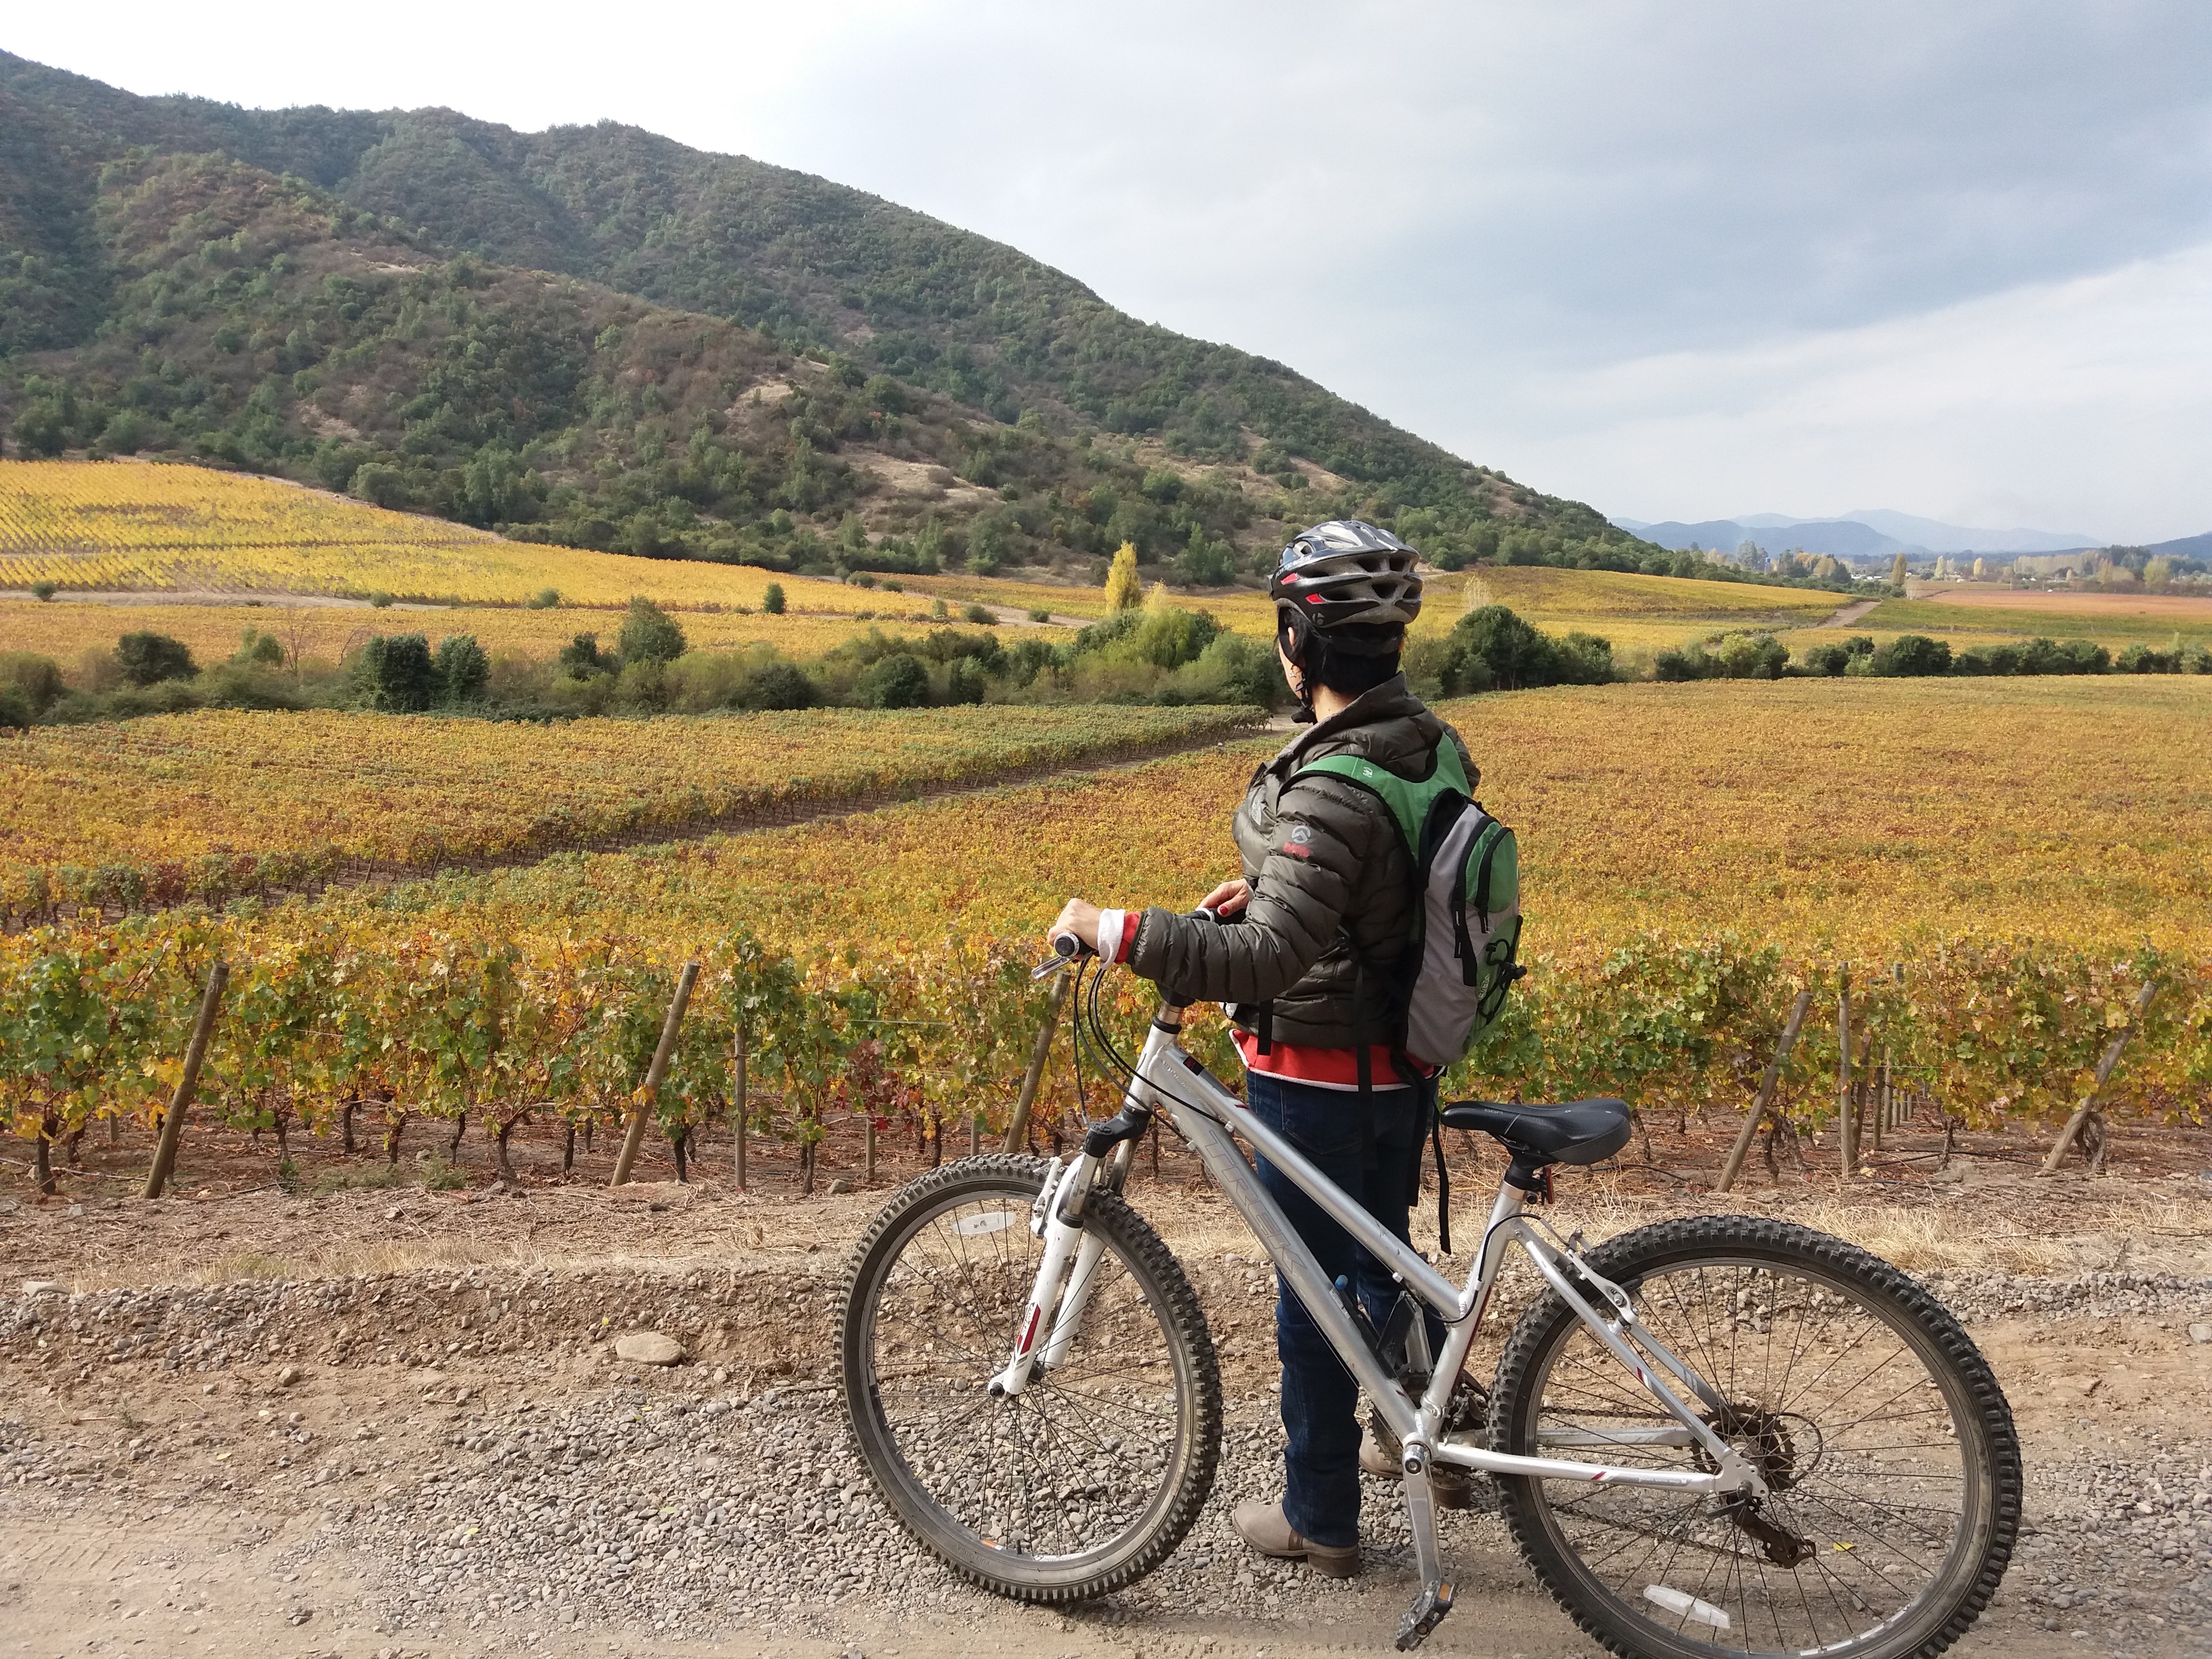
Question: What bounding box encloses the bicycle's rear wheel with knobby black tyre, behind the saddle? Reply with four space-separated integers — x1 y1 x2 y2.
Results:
1491 1216 2022 1659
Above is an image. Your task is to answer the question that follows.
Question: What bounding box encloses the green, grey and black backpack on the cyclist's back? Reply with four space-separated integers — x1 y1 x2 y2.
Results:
1298 737 1528 1068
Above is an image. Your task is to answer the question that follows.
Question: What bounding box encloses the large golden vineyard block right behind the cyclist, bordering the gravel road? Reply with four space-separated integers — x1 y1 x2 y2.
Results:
0 679 2212 1185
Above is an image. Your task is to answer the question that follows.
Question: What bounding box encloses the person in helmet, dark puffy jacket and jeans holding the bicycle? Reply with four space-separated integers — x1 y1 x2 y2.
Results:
1053 520 1478 1577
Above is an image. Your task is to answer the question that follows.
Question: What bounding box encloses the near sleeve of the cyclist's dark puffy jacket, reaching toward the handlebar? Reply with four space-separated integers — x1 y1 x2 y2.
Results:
1128 779 1373 1002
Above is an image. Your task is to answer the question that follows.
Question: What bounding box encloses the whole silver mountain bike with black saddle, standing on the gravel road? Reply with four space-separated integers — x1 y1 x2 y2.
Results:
839 938 2022 1659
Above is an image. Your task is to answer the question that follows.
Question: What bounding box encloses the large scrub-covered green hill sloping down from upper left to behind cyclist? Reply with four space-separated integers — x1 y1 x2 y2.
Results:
0 53 1665 582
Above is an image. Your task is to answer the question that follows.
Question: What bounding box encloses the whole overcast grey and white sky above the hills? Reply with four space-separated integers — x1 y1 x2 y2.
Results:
17 0 2212 540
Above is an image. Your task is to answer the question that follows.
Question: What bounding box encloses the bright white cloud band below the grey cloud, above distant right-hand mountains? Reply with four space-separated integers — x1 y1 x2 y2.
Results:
1495 243 2212 540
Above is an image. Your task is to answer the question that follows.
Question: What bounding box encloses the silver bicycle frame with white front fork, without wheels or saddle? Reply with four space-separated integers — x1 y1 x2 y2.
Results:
991 1006 1765 1504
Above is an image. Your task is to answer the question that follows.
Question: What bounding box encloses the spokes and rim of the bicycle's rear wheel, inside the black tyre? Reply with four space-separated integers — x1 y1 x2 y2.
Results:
1515 1259 1999 1653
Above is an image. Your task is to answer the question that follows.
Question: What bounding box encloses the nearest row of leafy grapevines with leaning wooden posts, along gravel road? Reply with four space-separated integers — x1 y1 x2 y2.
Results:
0 907 2212 1185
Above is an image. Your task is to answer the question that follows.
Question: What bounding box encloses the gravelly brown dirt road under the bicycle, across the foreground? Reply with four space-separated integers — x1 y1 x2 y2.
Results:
0 1168 2212 1659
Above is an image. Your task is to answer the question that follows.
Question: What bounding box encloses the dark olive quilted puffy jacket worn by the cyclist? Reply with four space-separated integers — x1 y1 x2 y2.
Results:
1130 675 1478 1049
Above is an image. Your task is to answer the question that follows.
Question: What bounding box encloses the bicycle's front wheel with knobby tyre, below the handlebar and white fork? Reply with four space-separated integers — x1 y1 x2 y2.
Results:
839 1157 1221 1602
